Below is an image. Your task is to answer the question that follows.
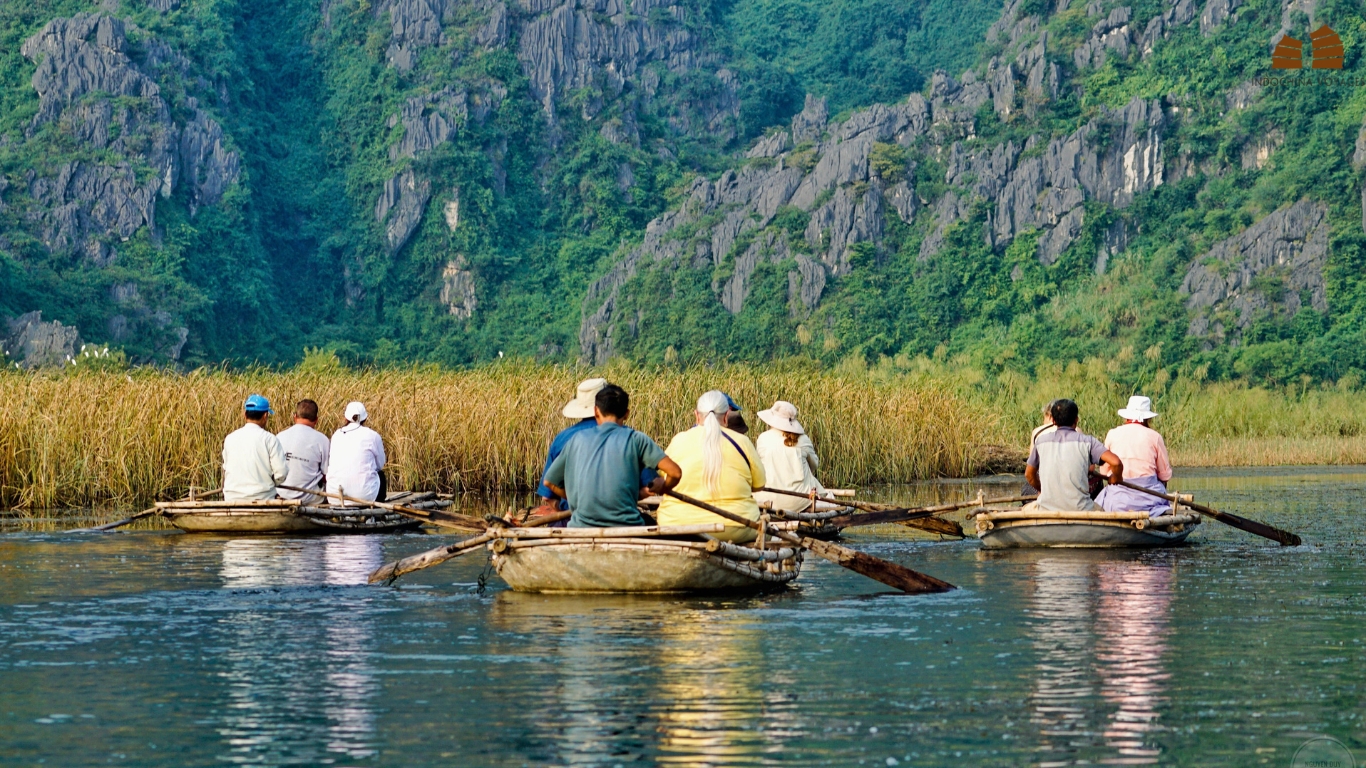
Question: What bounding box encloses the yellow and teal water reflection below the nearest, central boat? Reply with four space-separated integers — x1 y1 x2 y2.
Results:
493 592 805 765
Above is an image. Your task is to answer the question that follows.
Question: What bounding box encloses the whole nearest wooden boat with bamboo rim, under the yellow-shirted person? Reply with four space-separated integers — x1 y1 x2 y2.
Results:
488 523 802 594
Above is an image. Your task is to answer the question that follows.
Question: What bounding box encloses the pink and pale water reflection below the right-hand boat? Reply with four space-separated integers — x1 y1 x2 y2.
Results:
1027 552 1172 767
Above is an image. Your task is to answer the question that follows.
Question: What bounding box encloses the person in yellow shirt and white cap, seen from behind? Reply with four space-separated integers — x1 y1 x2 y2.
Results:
660 389 766 543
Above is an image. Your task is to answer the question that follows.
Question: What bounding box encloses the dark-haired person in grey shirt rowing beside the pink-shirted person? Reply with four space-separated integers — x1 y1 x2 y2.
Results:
1025 399 1124 512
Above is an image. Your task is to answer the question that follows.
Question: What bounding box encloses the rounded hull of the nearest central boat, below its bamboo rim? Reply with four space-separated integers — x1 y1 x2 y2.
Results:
493 540 800 594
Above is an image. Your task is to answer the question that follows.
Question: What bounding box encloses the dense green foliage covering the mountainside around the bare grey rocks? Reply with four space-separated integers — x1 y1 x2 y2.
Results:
0 0 1366 385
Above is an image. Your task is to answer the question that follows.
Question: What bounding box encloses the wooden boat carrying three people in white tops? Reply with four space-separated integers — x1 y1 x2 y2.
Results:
157 491 451 533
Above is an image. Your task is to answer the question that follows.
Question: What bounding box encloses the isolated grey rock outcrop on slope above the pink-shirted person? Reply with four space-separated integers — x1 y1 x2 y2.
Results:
1182 200 1329 336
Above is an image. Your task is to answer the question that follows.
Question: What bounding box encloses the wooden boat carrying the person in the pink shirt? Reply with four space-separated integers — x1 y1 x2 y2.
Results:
975 508 1201 549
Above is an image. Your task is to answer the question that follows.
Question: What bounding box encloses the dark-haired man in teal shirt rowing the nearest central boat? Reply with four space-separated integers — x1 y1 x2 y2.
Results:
541 384 683 527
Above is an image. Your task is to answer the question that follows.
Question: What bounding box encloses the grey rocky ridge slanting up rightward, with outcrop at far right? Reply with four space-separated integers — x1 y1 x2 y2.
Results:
579 0 1344 364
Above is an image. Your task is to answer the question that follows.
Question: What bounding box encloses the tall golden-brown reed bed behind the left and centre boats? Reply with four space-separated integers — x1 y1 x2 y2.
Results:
0 364 994 510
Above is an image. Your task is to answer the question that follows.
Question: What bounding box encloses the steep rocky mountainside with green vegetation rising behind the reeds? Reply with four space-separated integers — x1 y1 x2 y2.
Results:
0 0 1366 377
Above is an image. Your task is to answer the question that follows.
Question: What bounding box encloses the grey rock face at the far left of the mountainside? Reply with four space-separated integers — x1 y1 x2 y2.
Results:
4 12 240 361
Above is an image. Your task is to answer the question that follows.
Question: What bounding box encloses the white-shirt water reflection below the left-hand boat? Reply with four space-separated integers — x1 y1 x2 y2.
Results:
219 536 382 765
